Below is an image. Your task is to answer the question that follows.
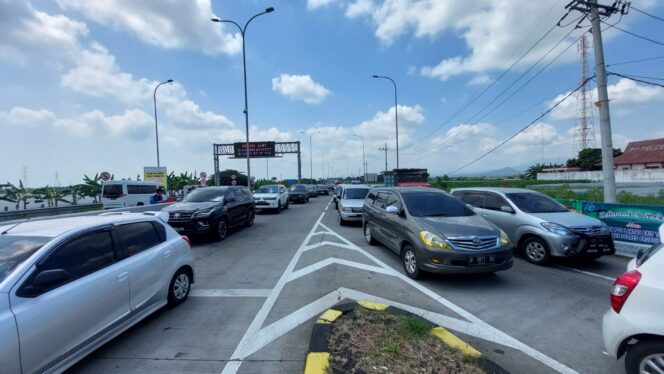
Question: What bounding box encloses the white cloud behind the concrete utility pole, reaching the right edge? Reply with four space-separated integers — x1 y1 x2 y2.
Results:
549 78 664 120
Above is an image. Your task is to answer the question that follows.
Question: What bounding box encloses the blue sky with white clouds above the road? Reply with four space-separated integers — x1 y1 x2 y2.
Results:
0 0 664 187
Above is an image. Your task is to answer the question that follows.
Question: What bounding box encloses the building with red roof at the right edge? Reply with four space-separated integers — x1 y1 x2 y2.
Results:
613 138 664 170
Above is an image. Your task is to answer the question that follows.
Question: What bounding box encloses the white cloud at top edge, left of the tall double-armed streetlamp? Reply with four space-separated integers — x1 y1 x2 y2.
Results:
57 0 242 55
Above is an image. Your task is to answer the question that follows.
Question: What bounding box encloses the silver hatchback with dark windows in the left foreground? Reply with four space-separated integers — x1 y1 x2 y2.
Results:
0 213 194 373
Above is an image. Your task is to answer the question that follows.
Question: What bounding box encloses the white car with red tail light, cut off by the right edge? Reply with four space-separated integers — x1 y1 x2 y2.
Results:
602 237 664 374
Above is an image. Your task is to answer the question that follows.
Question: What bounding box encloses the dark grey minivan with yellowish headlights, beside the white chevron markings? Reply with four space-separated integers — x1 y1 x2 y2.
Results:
362 187 513 278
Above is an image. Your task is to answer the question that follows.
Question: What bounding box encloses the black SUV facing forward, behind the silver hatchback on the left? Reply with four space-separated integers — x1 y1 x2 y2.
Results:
163 186 256 240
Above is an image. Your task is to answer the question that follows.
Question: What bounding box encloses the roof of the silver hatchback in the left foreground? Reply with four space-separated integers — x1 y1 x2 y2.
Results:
0 213 161 237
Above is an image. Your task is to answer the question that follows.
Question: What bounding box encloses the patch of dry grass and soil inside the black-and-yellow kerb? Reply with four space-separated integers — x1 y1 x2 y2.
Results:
330 308 484 374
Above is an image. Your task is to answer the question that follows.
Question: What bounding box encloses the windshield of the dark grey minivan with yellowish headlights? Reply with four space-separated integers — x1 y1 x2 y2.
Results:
403 192 475 217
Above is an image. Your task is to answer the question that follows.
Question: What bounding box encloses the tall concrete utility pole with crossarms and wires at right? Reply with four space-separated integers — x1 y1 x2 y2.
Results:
566 0 628 203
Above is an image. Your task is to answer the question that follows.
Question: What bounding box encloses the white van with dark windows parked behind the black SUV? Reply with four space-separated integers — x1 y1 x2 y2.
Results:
101 181 166 209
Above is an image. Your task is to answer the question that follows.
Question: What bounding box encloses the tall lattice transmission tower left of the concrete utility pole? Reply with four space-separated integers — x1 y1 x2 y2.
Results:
574 34 595 150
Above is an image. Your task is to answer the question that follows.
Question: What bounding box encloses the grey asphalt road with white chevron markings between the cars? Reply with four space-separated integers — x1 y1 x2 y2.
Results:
70 196 627 373
